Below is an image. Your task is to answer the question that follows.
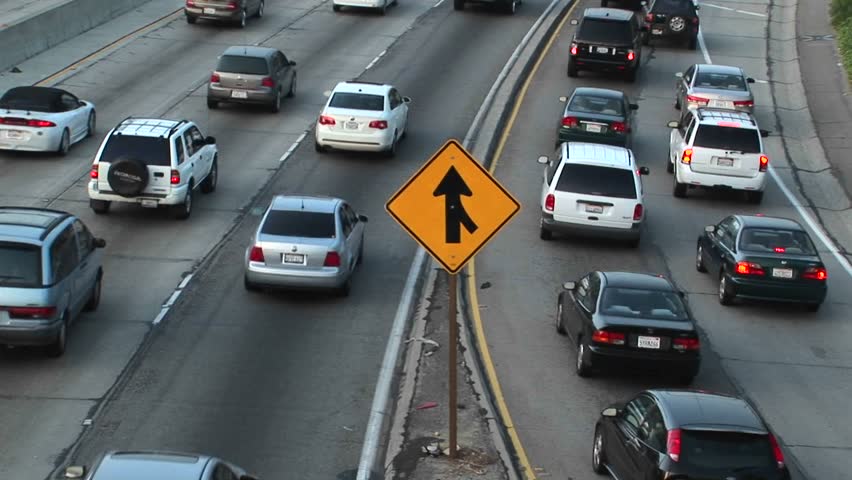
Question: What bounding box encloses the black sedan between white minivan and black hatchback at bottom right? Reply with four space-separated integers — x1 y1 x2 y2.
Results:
556 272 701 383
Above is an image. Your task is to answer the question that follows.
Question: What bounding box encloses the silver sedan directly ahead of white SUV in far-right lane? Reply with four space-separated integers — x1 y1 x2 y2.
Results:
675 64 754 113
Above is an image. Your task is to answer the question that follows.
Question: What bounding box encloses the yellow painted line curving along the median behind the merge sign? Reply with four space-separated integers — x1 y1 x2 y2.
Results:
467 0 580 480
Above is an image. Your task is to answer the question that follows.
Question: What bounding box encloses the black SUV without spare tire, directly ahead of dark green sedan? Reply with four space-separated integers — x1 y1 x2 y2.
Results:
568 8 643 82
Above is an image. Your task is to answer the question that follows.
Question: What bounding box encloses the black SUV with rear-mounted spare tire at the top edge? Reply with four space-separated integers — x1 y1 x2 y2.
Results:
643 0 698 50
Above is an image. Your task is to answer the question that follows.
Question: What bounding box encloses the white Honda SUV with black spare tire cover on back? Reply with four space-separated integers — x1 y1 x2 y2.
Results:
88 118 219 219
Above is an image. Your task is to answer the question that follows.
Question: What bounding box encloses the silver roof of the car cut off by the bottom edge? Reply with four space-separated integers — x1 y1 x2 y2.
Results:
92 451 211 480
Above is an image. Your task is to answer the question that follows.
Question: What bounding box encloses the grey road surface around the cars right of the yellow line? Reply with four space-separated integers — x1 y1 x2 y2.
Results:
472 2 852 480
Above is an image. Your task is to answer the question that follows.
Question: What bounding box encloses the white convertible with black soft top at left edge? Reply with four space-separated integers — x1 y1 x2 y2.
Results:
0 87 96 155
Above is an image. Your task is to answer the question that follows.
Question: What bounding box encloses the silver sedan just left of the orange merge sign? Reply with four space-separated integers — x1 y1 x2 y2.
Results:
245 195 367 296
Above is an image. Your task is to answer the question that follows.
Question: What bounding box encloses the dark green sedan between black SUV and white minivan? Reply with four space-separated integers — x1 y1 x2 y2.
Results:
556 87 639 148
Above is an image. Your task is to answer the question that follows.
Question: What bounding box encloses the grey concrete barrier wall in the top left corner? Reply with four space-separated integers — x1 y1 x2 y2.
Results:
0 0 156 71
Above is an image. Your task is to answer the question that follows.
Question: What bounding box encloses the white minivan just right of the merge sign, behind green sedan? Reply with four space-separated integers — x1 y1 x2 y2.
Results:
538 142 650 247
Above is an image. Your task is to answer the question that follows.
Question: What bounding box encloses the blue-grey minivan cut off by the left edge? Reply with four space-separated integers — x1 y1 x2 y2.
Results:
0 207 106 357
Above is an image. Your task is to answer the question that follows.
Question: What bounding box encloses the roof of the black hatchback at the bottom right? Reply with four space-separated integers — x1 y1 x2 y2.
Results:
648 389 768 433
